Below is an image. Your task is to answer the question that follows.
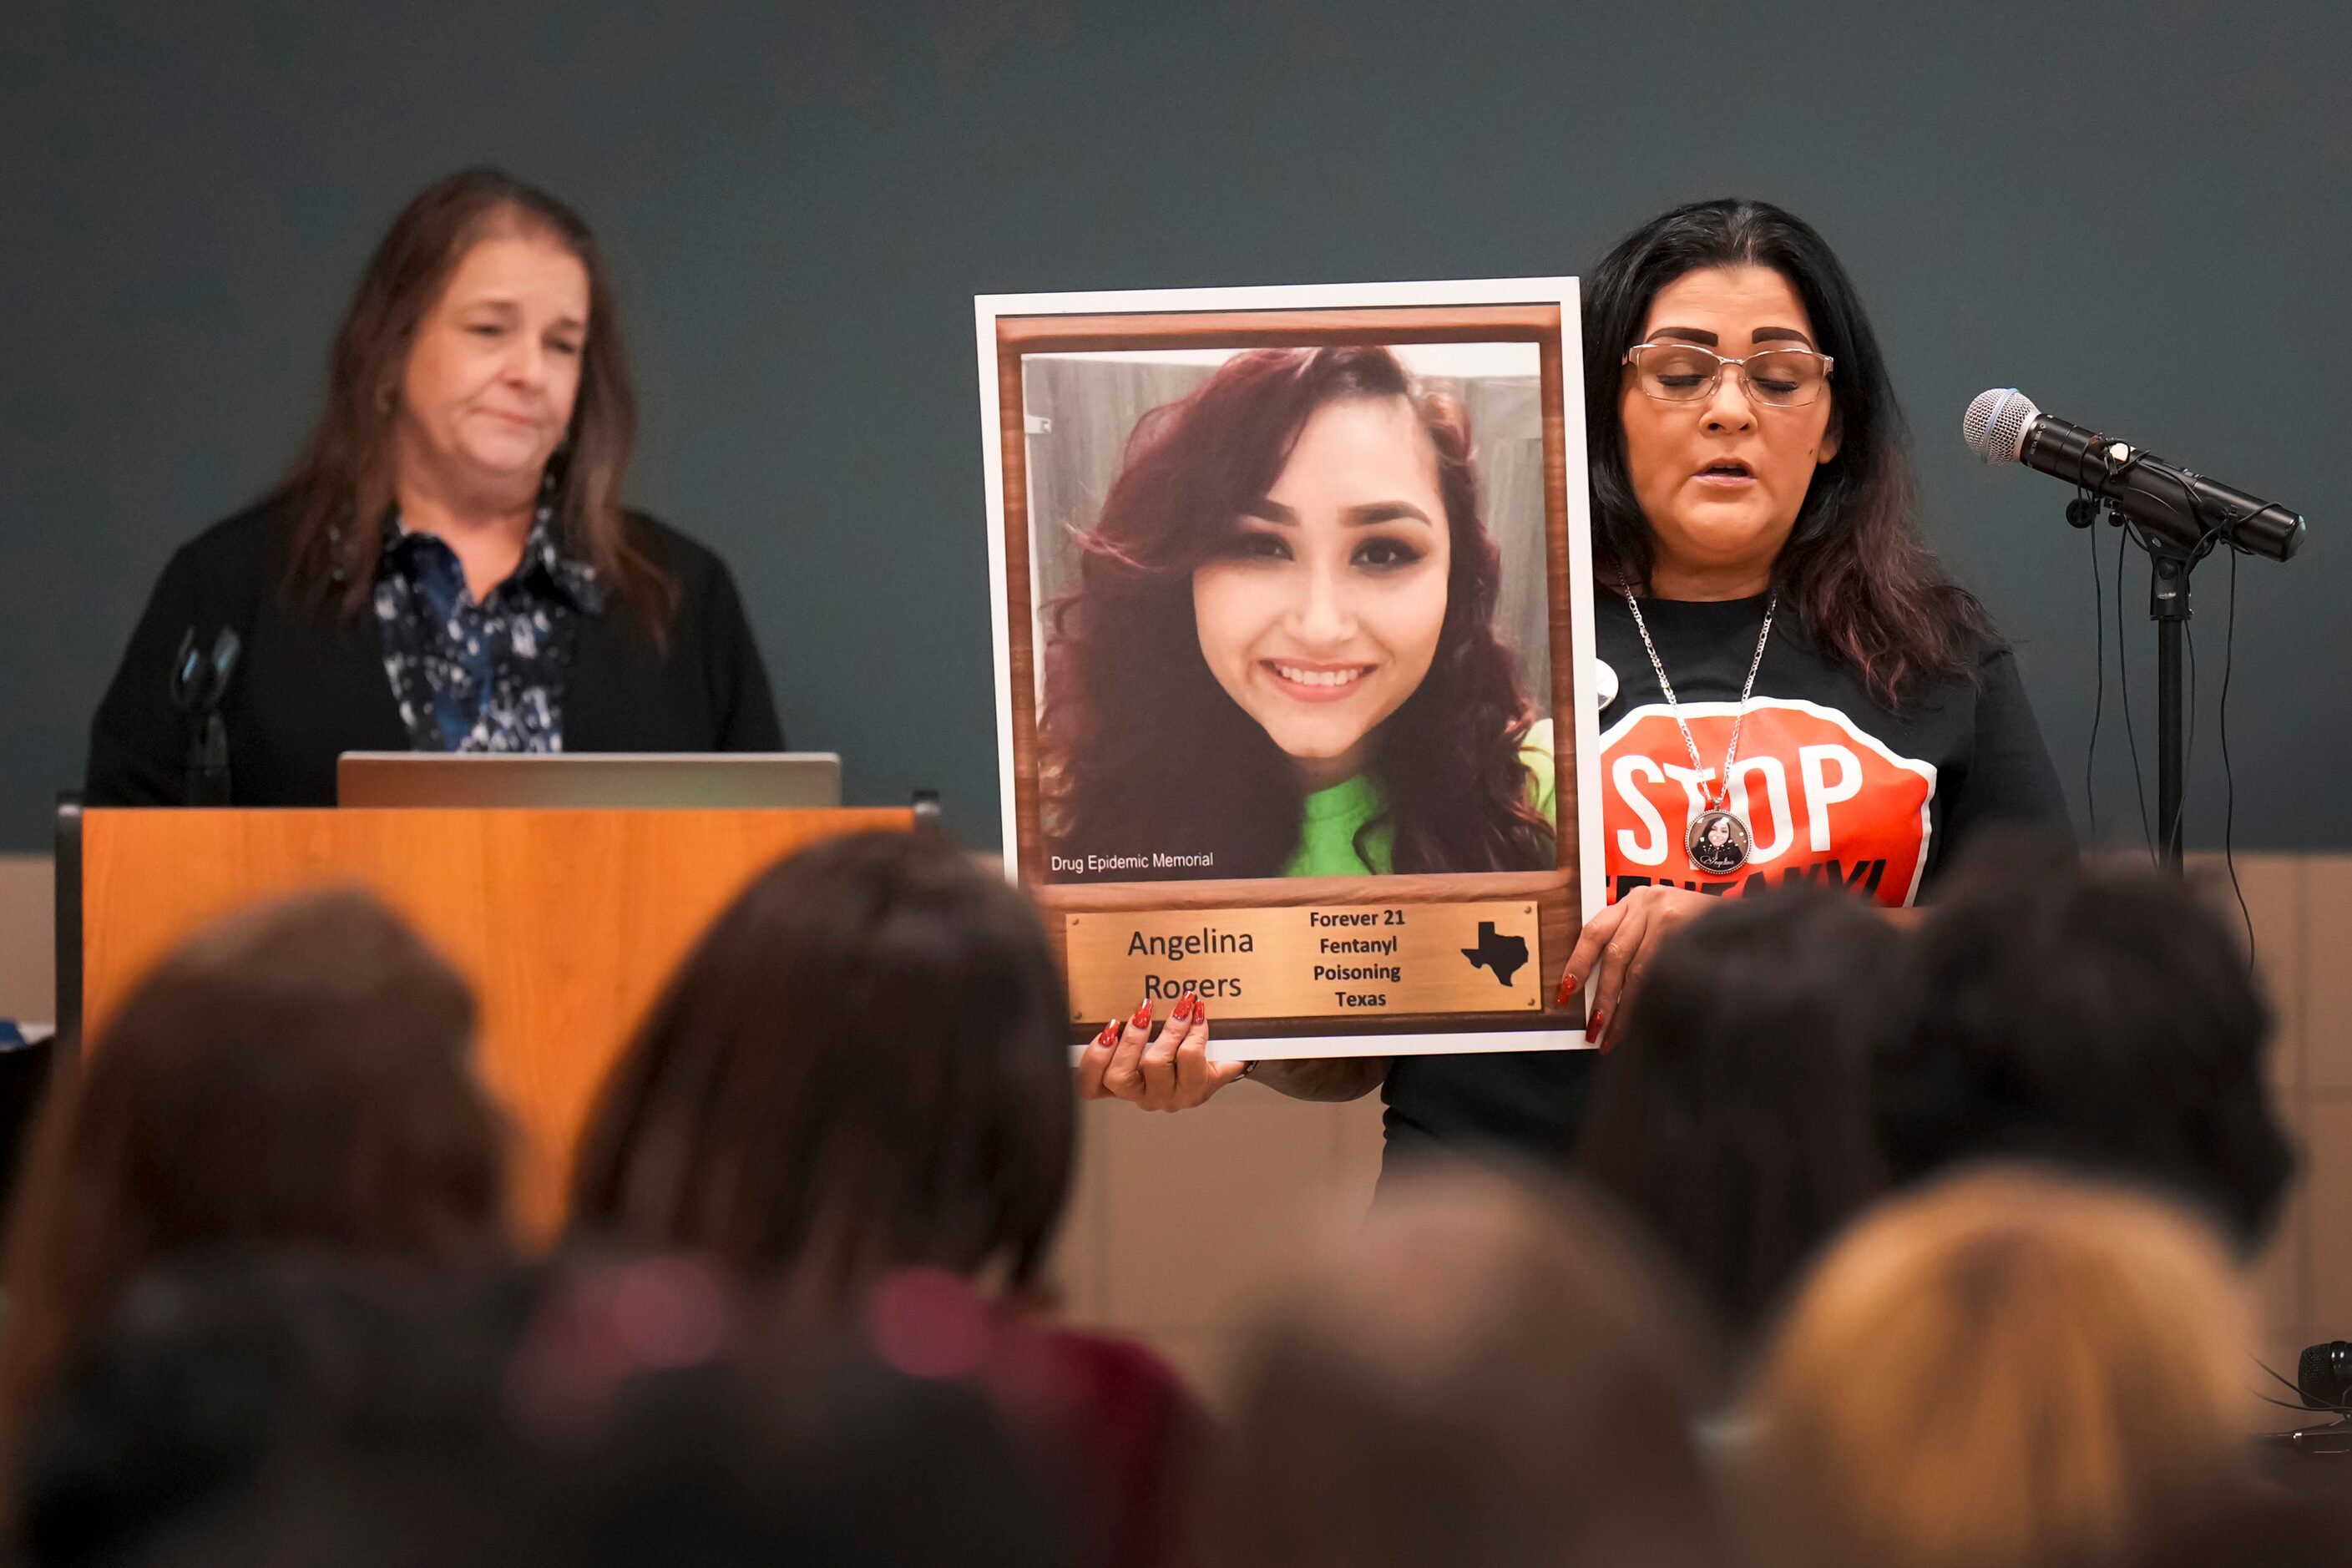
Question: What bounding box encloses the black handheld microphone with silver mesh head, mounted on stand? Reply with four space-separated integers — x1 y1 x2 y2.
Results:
1960 386 2303 562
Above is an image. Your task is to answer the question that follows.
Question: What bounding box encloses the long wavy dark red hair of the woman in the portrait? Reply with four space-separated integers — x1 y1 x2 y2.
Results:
1042 348 1555 877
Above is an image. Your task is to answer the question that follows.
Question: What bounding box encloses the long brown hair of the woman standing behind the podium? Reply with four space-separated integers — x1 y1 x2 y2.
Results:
277 169 677 642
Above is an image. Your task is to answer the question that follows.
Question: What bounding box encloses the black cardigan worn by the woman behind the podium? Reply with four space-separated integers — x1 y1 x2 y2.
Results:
84 501 783 807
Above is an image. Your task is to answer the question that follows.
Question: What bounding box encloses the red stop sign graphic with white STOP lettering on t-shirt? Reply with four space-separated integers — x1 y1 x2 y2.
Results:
1601 698 1935 905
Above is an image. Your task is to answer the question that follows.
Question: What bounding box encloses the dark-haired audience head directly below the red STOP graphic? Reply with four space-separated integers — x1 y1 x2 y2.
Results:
1578 891 1908 1340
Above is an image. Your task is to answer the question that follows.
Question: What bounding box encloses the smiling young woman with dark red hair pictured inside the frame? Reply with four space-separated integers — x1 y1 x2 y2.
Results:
1039 346 1555 882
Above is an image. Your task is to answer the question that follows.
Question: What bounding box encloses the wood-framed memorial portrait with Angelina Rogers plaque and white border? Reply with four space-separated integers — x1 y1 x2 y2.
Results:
976 277 1601 1058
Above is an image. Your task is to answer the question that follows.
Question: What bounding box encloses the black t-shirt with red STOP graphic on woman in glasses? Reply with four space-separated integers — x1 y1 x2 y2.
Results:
1383 590 2067 1156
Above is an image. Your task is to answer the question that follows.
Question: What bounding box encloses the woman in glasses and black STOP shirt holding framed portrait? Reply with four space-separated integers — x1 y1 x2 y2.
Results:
1080 200 2067 1154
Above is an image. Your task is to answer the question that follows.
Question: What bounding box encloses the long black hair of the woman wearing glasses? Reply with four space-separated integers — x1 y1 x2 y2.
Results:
1583 198 1995 706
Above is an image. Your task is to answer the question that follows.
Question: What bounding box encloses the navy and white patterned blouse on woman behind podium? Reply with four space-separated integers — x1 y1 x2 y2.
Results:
377 505 604 752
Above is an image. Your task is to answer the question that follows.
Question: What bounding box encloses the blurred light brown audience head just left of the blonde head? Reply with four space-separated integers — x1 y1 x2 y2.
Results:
1223 1171 1724 1568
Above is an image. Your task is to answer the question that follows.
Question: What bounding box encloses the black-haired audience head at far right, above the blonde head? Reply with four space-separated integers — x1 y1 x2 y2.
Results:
1877 839 2294 1251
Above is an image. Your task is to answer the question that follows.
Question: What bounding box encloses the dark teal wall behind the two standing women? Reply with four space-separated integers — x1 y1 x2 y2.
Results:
0 0 2352 848
